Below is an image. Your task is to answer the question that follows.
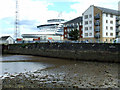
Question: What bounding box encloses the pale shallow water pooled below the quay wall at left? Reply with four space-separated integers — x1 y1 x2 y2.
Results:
0 55 59 75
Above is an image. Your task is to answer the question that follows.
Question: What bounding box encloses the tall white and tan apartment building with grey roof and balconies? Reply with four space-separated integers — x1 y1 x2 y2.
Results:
83 5 120 43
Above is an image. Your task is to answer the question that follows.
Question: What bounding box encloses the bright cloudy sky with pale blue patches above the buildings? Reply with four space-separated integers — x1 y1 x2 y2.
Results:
0 0 119 38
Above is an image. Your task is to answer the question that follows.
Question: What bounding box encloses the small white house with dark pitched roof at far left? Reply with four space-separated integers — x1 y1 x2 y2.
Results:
0 36 14 44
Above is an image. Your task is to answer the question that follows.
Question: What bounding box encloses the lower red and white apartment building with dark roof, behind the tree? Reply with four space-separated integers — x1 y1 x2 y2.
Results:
64 16 83 41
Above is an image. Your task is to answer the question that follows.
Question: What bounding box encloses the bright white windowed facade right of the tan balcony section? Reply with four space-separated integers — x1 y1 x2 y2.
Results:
102 13 116 38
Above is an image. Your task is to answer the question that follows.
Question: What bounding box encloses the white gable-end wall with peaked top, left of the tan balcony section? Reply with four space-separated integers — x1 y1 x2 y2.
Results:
83 6 94 38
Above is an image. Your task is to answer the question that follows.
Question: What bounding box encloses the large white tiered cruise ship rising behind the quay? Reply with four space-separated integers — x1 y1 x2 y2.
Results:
22 19 65 41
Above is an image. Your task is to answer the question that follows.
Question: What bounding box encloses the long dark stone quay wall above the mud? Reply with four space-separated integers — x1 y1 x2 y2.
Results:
3 43 120 62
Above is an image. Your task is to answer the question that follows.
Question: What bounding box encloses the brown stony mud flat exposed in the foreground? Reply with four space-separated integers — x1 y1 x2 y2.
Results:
0 61 120 89
